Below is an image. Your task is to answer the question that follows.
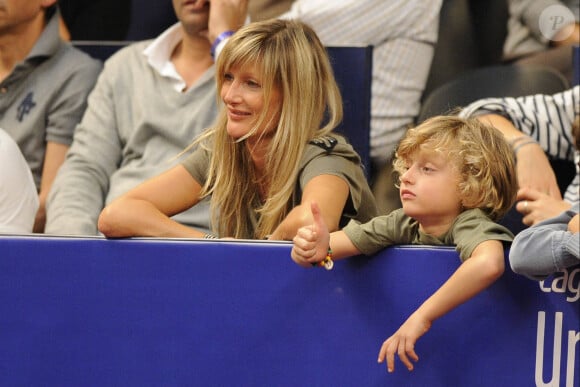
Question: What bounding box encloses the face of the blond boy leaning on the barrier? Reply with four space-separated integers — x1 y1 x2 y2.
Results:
399 149 461 227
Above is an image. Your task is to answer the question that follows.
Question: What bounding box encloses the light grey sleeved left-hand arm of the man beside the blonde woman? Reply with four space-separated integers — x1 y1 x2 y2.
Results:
45 68 122 235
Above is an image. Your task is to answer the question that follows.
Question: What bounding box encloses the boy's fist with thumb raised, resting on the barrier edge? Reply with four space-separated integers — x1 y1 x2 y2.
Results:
290 202 330 267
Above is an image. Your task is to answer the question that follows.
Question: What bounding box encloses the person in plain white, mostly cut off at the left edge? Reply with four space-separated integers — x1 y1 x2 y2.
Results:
0 129 38 234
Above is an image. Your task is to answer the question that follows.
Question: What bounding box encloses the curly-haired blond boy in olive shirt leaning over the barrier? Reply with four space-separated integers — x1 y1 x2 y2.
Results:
291 116 517 372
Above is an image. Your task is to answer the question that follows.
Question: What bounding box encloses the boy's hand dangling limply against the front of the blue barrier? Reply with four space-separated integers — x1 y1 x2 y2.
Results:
378 314 431 372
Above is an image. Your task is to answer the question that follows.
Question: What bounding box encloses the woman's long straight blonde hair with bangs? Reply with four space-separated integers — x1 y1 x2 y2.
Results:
195 20 342 239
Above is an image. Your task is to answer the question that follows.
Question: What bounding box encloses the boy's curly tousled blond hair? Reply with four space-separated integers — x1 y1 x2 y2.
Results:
393 115 518 221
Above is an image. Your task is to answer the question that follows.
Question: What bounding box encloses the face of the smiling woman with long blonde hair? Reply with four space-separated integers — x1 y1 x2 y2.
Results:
220 64 282 139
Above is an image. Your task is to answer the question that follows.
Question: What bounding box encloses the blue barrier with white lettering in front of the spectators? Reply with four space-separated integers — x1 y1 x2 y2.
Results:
0 236 580 387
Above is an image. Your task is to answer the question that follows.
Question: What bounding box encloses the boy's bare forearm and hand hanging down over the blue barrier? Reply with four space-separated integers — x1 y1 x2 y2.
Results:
378 240 505 372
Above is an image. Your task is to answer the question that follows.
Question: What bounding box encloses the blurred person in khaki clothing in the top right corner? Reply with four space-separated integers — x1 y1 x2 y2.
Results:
504 0 580 83
